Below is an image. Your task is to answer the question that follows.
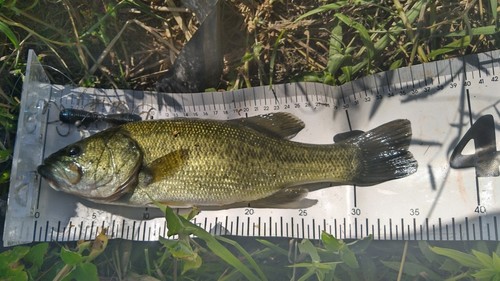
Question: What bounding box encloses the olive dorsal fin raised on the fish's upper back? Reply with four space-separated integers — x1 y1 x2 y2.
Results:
228 112 305 139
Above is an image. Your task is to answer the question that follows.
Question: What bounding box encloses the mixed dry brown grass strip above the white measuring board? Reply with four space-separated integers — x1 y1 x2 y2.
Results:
0 0 498 89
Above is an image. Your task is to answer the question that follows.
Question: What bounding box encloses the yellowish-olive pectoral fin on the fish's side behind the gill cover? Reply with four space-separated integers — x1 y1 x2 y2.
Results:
139 149 188 185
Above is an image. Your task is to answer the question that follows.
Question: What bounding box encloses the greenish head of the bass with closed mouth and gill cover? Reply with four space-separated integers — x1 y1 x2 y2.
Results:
37 128 142 201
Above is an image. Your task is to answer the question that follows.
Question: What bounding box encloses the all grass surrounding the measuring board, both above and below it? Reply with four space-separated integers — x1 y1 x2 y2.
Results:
0 0 500 280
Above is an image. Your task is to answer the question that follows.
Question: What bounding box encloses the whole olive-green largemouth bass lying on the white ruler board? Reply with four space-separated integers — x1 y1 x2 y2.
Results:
38 113 417 207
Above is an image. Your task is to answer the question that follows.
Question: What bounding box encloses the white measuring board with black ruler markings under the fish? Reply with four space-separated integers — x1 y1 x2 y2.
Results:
3 51 500 245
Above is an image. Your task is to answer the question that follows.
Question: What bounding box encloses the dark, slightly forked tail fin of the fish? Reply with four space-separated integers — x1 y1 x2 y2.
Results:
346 119 418 185
